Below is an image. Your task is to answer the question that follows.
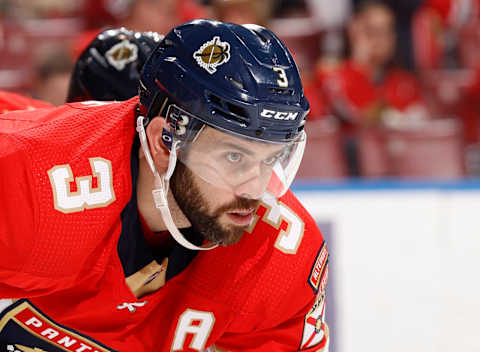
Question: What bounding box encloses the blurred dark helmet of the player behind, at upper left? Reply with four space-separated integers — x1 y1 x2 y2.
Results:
67 28 163 102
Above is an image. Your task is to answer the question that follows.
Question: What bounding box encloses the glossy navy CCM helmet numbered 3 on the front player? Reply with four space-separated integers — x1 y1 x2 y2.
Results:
140 20 309 143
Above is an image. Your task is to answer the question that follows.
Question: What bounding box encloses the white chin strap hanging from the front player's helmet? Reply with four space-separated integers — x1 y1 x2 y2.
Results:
137 115 218 251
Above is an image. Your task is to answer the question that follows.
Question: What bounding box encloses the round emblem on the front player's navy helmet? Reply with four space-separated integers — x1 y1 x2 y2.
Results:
193 36 230 74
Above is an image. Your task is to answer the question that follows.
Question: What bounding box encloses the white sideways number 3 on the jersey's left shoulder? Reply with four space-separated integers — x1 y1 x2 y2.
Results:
48 158 115 213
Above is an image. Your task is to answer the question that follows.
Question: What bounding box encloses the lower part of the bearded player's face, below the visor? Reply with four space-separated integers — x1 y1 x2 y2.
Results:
170 162 259 246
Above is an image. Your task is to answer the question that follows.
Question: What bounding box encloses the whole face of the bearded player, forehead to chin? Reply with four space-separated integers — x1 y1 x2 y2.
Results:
171 126 285 245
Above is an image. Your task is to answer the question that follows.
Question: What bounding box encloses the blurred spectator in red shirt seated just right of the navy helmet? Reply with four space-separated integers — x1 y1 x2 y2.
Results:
314 1 426 176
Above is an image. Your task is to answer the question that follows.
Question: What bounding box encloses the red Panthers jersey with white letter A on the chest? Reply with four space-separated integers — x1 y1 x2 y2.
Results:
0 98 329 352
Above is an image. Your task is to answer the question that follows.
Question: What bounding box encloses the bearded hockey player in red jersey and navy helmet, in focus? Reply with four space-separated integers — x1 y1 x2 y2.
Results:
0 20 329 352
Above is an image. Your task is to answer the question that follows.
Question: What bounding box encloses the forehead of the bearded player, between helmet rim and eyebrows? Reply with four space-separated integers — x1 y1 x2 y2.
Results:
190 125 284 155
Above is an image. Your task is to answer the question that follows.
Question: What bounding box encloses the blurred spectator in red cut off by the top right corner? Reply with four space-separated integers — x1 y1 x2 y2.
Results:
413 0 480 144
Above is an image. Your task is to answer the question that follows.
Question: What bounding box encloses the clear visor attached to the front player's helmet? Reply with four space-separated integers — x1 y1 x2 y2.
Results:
166 106 306 199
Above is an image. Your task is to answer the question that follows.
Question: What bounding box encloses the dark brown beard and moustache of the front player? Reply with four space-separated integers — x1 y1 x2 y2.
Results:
170 161 260 246
